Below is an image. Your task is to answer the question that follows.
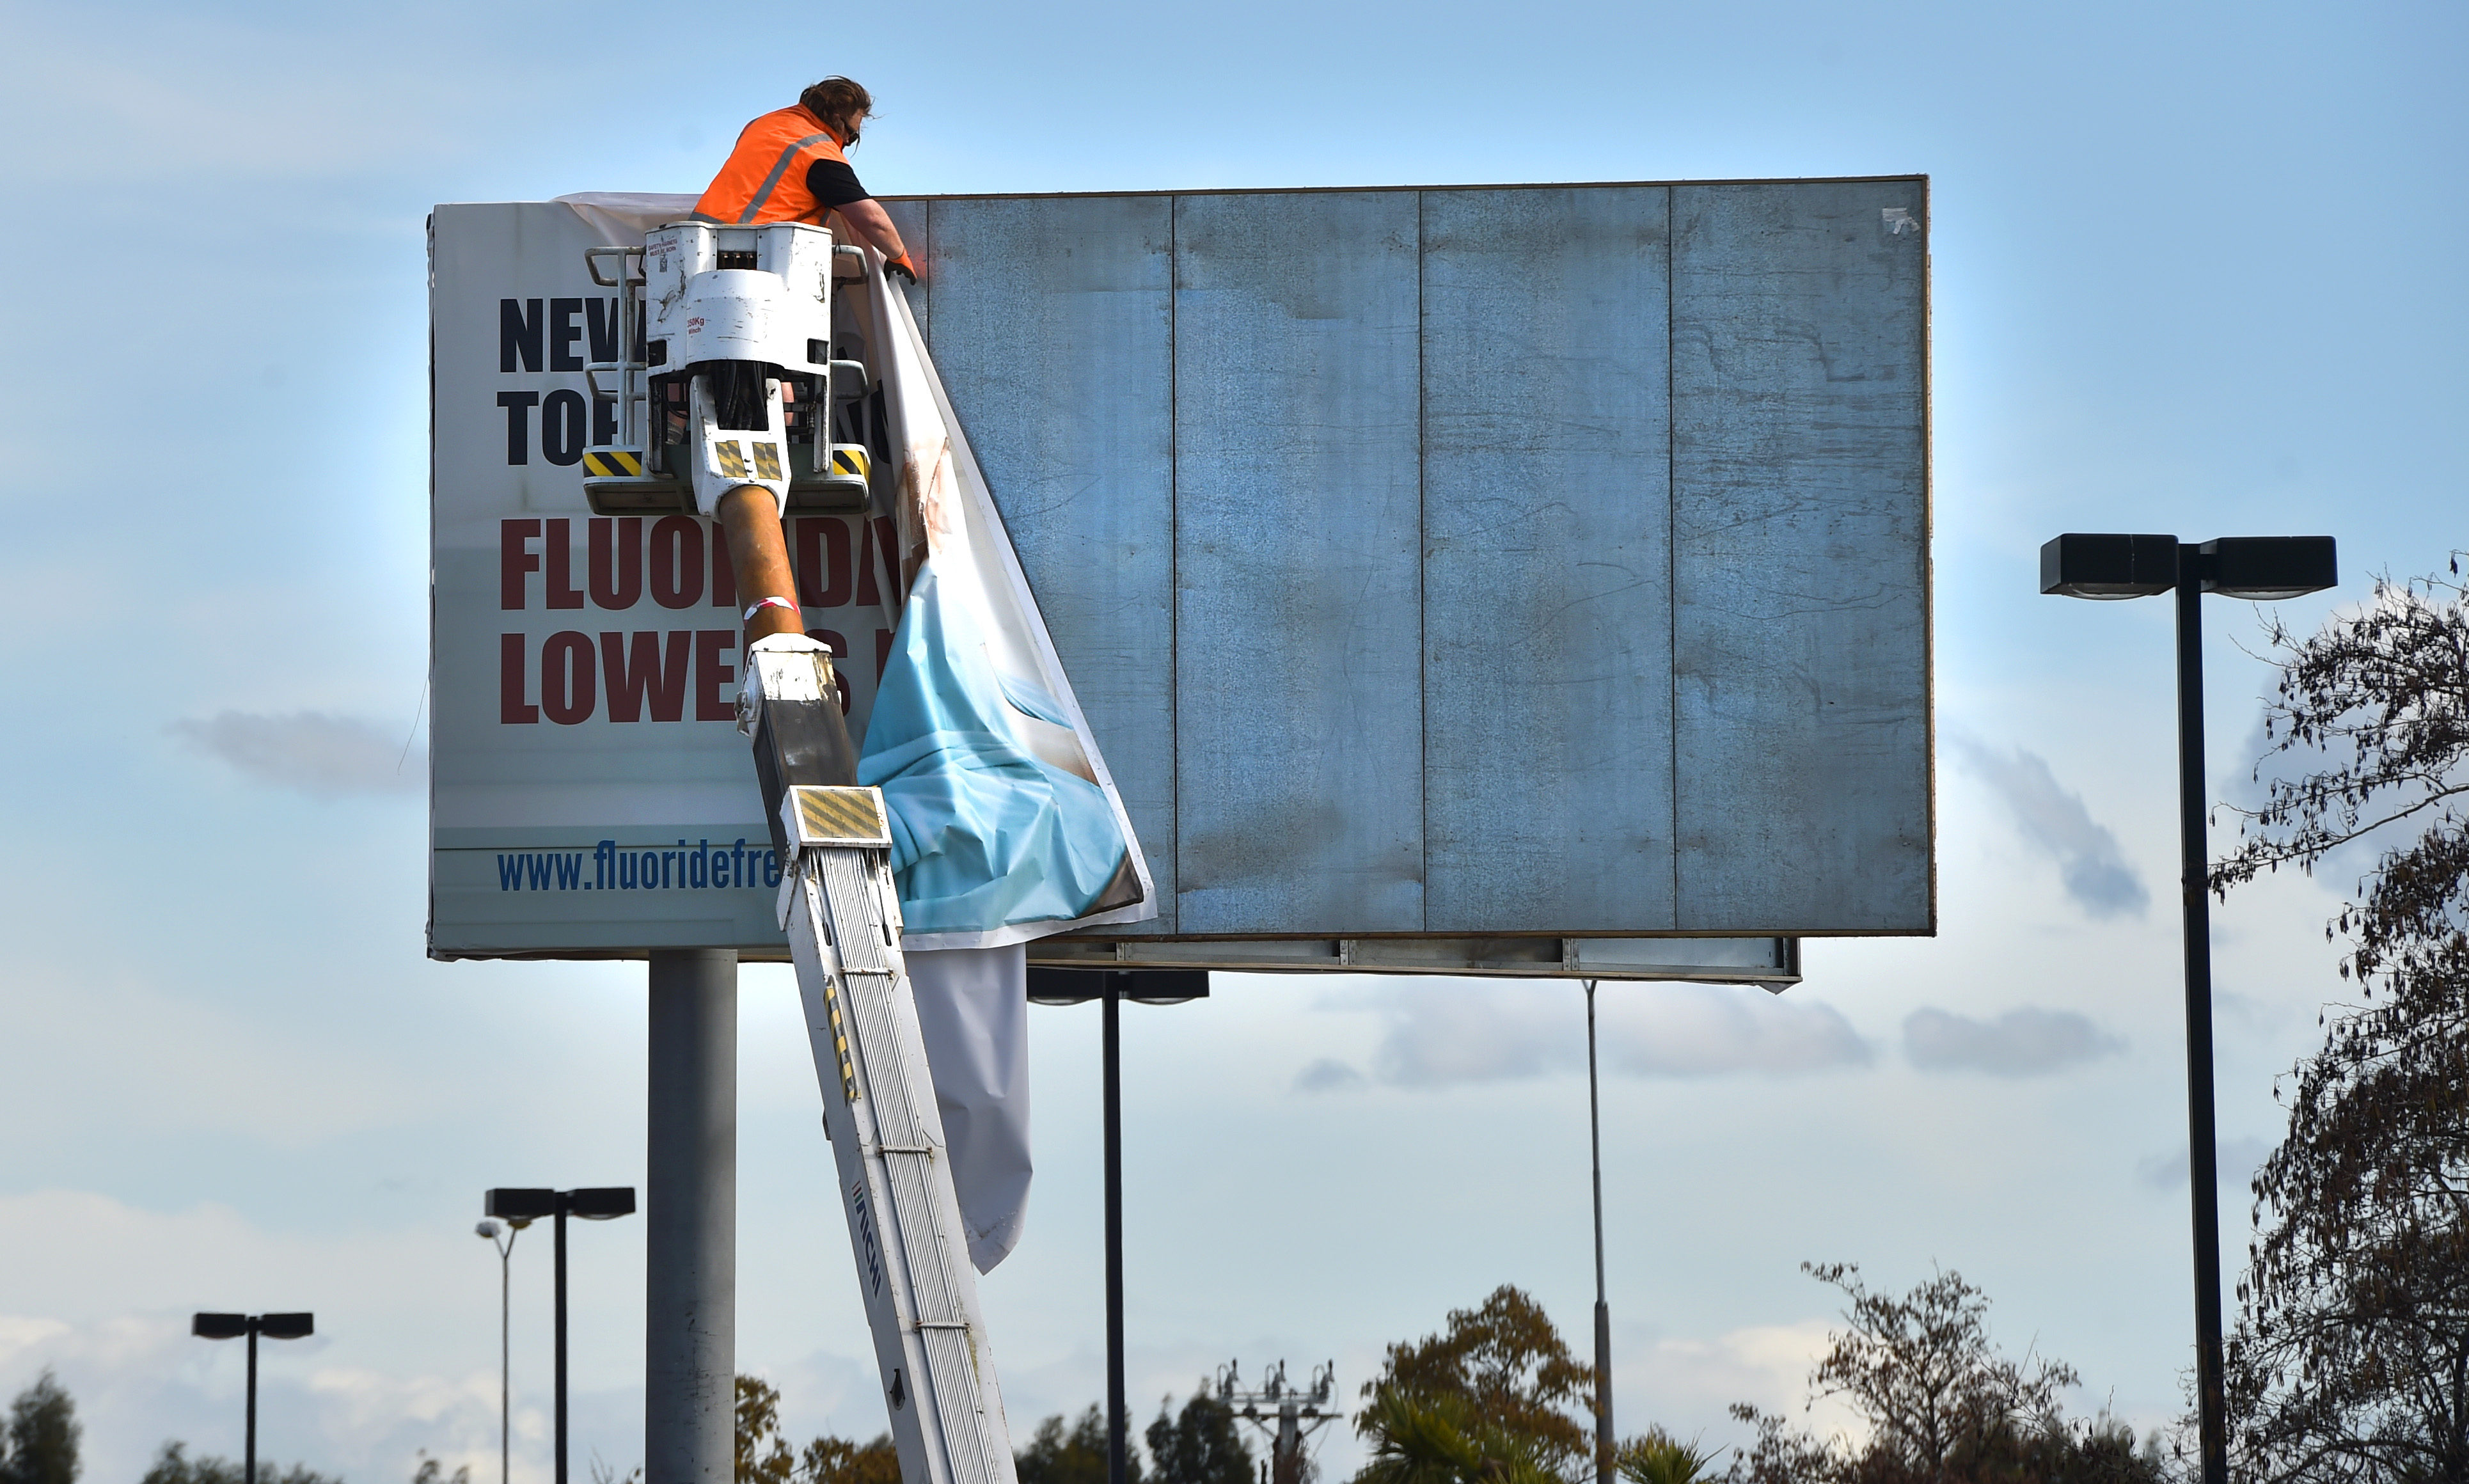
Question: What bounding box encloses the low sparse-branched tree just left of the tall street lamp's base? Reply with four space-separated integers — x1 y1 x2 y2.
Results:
1731 1262 2163 1484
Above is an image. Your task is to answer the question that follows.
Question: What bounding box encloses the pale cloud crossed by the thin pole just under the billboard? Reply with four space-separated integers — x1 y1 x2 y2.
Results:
1373 981 1872 1087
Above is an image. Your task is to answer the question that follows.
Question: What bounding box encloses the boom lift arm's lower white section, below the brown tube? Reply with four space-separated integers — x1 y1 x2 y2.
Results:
738 635 1014 1484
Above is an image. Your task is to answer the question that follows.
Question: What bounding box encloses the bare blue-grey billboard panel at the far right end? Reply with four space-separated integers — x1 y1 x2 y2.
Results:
1671 180 1933 933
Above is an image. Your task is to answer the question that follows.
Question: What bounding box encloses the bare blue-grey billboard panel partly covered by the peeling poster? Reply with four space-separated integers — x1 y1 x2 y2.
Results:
921 195 1175 933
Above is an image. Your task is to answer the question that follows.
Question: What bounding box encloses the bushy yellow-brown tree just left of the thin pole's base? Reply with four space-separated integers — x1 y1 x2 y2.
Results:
1355 1284 1595 1484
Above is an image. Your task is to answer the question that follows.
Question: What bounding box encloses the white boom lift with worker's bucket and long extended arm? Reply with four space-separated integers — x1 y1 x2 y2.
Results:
585 222 1014 1484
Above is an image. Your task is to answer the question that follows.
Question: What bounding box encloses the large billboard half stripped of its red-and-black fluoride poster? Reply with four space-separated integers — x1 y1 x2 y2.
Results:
430 178 1936 978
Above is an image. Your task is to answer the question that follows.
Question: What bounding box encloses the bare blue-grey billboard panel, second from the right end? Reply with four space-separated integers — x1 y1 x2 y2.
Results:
1422 187 1674 933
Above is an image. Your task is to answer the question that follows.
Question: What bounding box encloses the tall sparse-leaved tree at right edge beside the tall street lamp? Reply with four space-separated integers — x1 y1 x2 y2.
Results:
2213 553 2469 1479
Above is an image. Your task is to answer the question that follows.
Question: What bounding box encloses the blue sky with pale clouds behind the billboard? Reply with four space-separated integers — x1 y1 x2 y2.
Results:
0 0 2469 1484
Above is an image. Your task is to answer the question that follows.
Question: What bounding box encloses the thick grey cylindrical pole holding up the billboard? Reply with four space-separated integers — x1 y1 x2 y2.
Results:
642 948 738 1484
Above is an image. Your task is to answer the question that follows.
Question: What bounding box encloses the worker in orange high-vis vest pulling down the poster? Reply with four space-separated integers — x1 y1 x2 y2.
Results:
694 77 919 284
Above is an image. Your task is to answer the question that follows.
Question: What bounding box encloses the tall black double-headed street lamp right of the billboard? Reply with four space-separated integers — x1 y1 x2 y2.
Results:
2039 523 2340 1484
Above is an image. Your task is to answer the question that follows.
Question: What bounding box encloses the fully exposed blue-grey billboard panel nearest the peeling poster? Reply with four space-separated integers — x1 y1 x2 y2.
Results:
1175 193 1424 933
